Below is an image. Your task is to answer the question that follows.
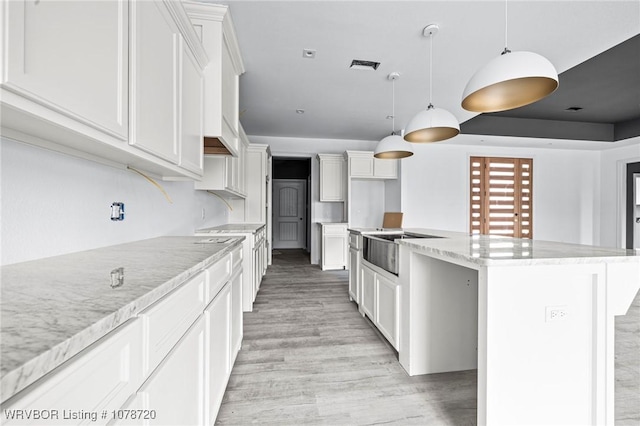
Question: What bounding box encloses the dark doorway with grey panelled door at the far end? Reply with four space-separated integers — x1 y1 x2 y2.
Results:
272 157 311 251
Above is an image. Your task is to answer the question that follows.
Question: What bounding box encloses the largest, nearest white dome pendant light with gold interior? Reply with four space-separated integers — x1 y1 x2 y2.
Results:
462 0 558 112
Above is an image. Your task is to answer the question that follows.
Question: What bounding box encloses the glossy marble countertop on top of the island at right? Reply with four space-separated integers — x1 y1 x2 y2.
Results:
399 232 640 266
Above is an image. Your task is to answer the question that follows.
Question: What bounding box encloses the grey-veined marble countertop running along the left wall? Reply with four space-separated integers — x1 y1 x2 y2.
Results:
0 237 244 400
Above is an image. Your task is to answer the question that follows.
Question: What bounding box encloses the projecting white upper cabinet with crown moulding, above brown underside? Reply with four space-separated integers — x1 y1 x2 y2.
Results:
183 1 244 156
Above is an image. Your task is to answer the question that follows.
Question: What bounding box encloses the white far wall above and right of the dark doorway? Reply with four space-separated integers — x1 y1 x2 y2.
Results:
249 135 377 264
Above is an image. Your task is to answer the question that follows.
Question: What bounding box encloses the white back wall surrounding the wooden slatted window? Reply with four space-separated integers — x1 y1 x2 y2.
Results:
402 143 600 244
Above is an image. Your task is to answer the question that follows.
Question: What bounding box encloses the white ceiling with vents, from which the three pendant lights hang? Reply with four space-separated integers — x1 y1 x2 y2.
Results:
210 0 640 149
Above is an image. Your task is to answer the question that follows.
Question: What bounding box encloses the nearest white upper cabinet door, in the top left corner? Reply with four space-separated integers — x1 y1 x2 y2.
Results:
1 1 129 140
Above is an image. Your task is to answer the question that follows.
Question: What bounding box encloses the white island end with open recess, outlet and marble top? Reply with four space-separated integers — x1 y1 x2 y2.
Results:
398 230 640 425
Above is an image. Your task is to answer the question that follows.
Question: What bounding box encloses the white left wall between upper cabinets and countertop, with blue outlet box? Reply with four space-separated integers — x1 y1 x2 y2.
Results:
0 139 228 265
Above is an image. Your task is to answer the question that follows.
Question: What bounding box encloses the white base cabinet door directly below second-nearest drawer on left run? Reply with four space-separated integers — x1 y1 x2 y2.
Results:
140 316 205 426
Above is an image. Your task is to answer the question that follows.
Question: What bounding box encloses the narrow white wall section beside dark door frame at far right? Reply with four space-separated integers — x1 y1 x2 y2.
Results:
599 137 640 248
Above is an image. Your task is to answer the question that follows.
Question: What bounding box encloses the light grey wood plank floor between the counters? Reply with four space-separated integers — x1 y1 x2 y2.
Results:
217 250 640 426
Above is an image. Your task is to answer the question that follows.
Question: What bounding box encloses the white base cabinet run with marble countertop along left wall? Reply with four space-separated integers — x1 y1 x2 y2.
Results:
0 237 243 425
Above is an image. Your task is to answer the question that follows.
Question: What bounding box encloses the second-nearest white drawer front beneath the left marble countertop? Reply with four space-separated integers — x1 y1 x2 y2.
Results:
140 272 207 374
